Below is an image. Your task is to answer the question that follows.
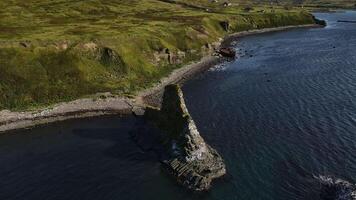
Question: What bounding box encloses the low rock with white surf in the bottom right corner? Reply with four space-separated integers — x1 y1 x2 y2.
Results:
315 176 356 200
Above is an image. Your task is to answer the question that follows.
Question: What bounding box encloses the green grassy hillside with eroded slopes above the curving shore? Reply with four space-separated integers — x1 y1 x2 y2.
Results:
0 0 314 110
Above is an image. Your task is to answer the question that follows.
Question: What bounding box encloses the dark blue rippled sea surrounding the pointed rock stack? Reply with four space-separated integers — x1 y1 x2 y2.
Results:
0 12 356 200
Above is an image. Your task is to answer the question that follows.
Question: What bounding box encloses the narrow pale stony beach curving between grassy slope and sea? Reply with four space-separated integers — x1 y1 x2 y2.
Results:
0 24 322 134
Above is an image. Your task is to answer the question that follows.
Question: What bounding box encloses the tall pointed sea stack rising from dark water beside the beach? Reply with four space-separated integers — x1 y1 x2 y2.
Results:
145 85 226 191
